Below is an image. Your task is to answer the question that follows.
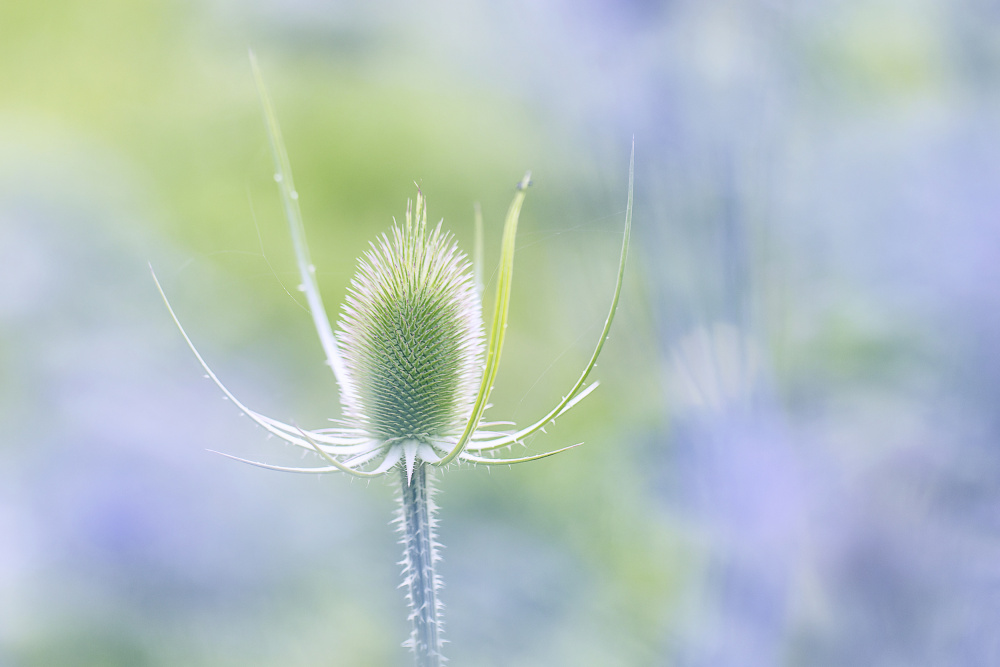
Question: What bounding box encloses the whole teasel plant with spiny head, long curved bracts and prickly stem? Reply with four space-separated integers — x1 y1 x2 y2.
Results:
150 53 635 667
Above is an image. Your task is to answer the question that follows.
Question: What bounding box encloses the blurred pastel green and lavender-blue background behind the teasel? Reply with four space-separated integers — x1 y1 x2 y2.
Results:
0 0 1000 667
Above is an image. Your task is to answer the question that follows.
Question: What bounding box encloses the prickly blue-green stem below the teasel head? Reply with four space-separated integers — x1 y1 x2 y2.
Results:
399 463 444 667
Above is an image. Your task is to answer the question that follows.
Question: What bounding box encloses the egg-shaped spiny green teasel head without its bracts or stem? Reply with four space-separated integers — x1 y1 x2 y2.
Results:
337 191 485 441
